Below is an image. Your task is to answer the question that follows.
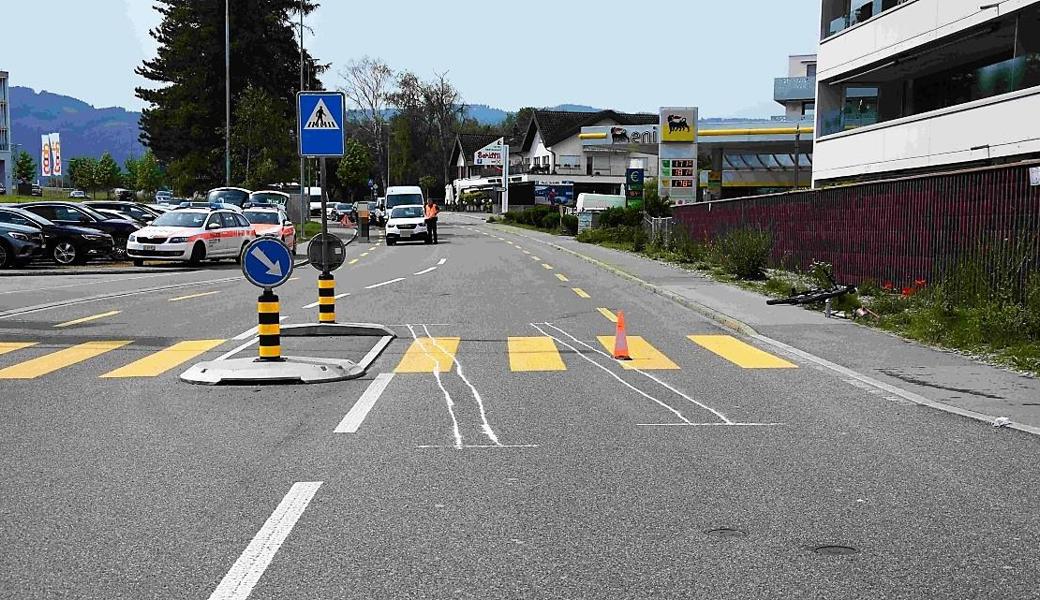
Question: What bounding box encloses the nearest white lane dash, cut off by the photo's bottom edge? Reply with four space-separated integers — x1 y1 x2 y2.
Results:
209 481 321 600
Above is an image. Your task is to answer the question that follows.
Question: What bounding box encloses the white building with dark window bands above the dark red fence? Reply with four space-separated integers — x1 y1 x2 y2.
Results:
813 0 1040 184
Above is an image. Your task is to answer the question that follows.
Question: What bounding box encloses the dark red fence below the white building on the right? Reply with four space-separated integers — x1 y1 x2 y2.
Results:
673 163 1040 286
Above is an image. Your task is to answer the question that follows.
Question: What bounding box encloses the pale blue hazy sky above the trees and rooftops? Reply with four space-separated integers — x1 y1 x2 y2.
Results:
0 0 820 116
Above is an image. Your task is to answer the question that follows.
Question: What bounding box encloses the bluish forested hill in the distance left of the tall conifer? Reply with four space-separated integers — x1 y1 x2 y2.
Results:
10 86 145 166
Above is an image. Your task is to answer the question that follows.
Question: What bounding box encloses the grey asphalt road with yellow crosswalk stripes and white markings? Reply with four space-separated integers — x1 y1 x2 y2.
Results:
0 215 1040 600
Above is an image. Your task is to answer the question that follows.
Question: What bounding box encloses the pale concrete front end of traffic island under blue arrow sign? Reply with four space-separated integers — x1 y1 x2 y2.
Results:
181 357 365 386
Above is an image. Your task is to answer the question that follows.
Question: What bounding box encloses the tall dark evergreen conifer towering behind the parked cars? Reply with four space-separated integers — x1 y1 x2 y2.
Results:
136 0 328 190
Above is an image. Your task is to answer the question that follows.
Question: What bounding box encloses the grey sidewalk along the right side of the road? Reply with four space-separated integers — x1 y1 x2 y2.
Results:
496 217 1040 434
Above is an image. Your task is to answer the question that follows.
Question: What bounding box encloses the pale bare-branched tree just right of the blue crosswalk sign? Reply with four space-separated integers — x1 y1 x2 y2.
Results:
339 56 394 188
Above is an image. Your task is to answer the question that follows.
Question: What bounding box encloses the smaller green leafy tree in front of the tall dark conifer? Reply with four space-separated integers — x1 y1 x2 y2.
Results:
231 85 293 189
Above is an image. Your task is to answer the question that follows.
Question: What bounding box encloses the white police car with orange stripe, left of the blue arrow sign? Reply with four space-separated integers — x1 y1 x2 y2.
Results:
127 208 256 266
